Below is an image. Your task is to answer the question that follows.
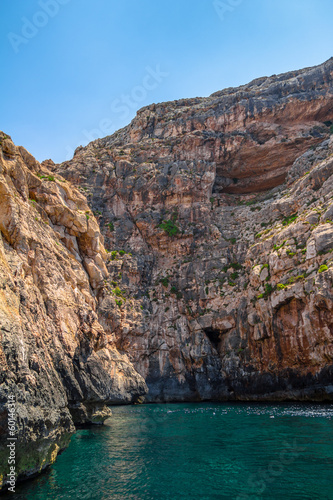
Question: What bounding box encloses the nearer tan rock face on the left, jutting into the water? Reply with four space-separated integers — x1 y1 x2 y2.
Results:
0 133 146 486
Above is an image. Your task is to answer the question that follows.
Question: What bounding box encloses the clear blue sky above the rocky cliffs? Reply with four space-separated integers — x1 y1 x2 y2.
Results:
0 0 333 162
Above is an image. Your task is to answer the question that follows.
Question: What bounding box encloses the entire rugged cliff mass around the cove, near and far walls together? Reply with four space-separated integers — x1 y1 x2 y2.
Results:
0 59 333 488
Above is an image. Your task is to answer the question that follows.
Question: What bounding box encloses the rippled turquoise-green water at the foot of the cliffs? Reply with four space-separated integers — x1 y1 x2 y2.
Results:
11 403 333 500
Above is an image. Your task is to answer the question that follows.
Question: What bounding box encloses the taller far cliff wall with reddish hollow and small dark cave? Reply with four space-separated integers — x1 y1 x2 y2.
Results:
52 59 333 401
